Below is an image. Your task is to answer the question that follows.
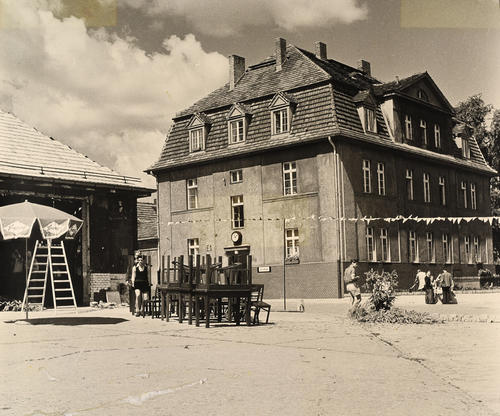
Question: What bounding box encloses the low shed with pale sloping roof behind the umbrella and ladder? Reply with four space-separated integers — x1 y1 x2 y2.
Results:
0 111 154 305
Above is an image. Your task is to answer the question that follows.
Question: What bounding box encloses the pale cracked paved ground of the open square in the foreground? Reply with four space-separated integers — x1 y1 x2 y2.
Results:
0 294 500 416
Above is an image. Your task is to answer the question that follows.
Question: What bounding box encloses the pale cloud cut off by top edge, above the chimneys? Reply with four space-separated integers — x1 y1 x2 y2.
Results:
122 0 368 36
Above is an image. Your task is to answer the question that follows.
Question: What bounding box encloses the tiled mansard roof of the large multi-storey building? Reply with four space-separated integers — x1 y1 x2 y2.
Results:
149 40 493 173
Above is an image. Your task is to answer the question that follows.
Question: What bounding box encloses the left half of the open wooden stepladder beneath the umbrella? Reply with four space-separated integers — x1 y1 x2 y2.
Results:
21 240 49 310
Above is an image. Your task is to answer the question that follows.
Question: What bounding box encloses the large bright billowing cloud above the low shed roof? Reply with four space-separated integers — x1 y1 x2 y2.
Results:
0 0 227 185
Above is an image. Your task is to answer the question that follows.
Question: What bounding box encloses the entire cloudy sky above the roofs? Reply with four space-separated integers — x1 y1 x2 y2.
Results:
0 0 500 186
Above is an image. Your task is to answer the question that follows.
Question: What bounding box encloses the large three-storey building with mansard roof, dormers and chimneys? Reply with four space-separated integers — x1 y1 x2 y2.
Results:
150 39 495 298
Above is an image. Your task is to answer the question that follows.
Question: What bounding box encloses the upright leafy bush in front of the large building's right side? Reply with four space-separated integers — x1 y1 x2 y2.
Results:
364 269 399 311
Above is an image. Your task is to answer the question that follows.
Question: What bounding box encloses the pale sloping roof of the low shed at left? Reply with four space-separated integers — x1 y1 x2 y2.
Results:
0 110 155 194
